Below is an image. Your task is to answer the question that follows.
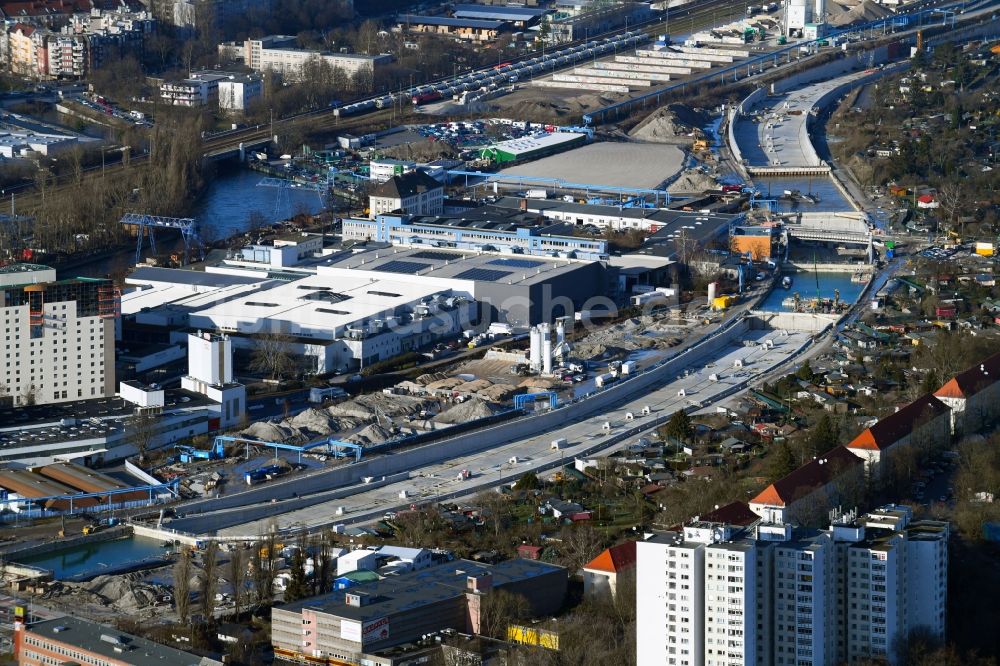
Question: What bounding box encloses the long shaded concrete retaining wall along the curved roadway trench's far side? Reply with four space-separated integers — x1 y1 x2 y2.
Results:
169 318 750 532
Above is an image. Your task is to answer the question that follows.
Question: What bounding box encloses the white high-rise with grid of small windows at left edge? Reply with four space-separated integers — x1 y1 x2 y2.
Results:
0 264 117 406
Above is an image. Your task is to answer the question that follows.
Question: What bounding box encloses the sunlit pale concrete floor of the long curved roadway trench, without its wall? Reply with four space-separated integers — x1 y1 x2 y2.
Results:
213 330 810 537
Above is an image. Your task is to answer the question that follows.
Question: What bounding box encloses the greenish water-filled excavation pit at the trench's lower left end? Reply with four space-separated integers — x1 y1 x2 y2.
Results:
18 536 170 580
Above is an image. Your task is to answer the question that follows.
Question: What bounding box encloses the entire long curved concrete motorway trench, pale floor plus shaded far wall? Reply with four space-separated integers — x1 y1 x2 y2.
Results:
164 315 812 537
